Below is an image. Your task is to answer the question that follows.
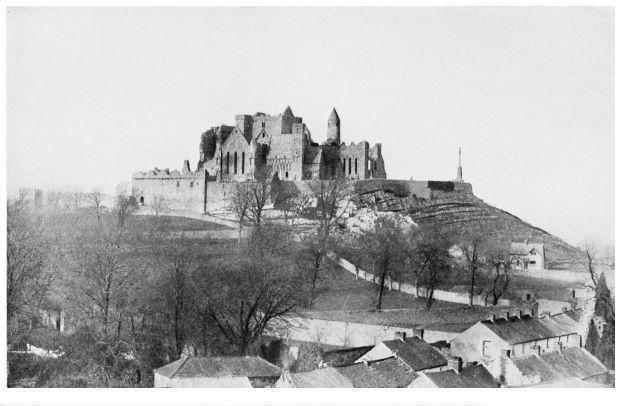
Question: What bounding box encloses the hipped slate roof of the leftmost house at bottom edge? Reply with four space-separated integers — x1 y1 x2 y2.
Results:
155 357 280 379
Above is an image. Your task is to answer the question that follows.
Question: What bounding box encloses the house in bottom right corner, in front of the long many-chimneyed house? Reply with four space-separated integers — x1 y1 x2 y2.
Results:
486 347 609 387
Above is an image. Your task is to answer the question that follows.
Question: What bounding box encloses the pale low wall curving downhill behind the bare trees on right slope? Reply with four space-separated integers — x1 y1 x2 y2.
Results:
330 254 513 306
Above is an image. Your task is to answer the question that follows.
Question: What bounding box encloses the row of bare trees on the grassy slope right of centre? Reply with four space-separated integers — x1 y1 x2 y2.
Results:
344 216 511 309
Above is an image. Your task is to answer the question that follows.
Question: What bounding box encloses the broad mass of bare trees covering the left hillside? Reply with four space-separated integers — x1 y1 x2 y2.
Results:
7 182 322 386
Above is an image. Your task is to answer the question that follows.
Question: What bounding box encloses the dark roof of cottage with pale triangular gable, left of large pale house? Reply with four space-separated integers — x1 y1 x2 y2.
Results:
383 337 448 371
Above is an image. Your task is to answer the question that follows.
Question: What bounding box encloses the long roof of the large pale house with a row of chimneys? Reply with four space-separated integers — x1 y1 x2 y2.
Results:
481 313 579 344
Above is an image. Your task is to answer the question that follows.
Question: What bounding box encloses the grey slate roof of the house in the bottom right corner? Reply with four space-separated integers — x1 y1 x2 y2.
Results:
511 347 607 383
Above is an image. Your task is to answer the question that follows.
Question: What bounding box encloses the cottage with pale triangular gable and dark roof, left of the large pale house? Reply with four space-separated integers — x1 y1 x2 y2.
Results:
356 333 448 372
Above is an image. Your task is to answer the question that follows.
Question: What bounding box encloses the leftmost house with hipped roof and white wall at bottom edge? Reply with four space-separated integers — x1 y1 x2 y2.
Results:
154 357 280 388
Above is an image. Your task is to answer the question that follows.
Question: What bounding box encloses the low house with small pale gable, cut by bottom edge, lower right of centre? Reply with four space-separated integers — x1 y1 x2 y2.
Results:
409 358 500 388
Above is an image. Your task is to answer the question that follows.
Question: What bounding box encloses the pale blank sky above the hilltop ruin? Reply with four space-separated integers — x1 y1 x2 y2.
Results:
6 7 614 244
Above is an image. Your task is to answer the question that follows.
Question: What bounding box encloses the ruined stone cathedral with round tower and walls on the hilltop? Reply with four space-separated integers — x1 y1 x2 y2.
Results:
132 107 471 212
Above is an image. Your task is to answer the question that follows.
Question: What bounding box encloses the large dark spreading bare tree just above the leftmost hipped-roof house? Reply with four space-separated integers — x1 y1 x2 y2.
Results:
195 225 306 354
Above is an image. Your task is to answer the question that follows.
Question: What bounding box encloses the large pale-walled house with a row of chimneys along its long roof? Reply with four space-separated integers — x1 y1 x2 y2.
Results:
450 310 582 362
